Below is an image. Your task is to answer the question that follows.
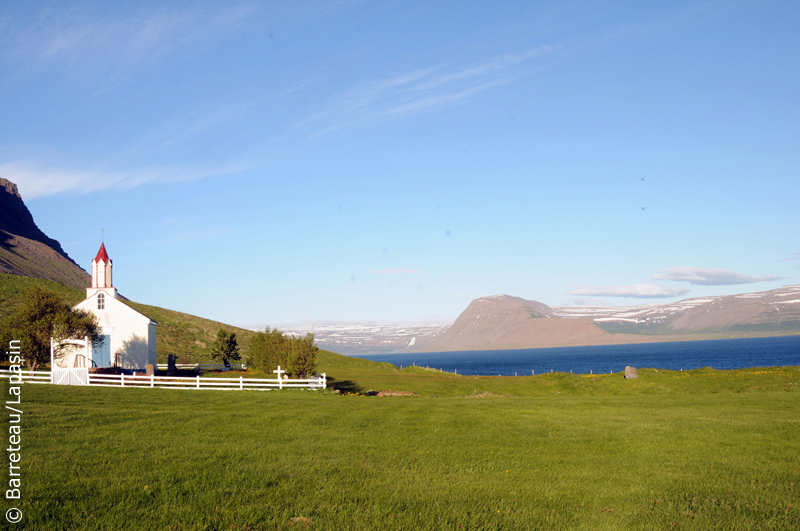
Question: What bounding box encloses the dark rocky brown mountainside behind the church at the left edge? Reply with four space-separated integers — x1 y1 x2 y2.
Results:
0 179 91 290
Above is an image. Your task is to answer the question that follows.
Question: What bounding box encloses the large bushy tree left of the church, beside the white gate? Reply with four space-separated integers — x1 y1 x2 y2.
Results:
1 286 100 371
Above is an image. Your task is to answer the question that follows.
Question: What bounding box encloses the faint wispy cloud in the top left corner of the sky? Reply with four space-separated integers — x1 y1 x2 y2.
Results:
0 4 259 82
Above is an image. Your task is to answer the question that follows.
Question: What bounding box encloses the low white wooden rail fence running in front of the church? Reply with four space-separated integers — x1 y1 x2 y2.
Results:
0 368 328 391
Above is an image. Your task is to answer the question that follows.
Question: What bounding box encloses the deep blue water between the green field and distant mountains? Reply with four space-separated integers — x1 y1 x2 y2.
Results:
358 336 800 376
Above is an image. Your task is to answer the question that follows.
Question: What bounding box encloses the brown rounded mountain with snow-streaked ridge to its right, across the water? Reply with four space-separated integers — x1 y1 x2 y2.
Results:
413 286 800 352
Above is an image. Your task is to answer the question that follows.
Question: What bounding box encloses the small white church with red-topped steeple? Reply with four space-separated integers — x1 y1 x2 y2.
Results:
56 243 158 371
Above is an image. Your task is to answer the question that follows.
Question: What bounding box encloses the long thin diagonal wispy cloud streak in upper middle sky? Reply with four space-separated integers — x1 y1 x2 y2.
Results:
295 45 562 136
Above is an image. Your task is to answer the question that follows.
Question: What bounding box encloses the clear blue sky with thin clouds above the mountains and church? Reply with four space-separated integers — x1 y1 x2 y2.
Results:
0 1 800 325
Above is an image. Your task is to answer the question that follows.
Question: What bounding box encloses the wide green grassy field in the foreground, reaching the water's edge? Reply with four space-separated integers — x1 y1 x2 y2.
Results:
2 364 800 530
